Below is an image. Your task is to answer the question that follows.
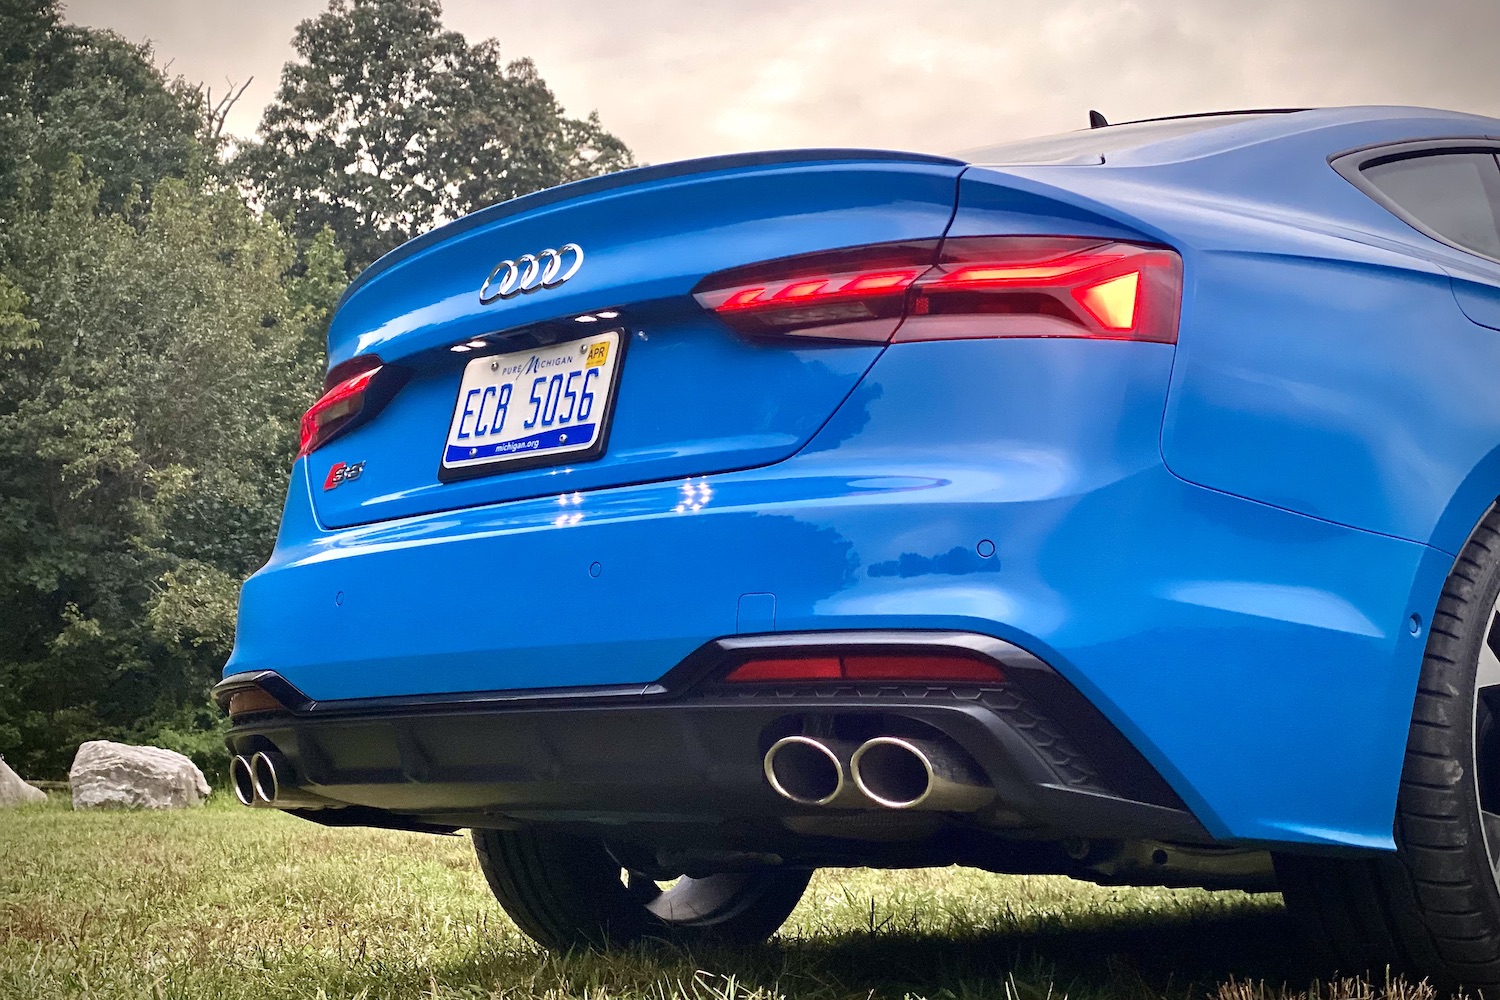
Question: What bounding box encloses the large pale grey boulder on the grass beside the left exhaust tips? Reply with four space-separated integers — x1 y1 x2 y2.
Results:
68 739 209 810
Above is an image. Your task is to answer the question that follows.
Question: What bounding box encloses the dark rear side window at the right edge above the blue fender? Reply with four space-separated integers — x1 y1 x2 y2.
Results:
1362 150 1500 259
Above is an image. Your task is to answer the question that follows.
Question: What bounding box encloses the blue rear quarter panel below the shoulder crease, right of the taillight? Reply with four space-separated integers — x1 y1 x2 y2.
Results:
1163 242 1500 552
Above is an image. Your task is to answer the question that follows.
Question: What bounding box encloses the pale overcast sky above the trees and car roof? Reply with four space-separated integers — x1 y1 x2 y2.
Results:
65 0 1500 163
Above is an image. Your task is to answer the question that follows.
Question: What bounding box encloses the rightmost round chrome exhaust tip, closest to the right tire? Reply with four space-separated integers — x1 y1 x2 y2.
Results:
849 736 995 813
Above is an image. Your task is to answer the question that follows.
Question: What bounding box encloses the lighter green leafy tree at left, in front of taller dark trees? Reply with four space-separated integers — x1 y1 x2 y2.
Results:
0 164 342 775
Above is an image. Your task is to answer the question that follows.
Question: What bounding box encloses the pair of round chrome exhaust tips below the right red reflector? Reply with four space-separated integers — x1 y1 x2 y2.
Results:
765 736 995 813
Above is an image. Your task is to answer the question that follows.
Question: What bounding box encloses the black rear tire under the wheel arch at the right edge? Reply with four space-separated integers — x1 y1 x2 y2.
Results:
1277 508 1500 994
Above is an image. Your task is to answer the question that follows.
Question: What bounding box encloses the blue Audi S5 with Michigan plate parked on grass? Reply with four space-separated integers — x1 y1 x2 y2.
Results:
216 108 1500 988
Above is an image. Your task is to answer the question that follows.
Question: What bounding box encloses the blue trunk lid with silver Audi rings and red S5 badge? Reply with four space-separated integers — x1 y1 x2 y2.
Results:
303 151 963 528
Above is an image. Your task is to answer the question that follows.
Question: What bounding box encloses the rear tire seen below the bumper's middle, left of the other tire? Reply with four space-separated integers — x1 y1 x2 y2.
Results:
474 831 813 951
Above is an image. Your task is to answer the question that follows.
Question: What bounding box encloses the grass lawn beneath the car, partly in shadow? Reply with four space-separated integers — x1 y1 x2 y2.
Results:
0 796 1452 1000
